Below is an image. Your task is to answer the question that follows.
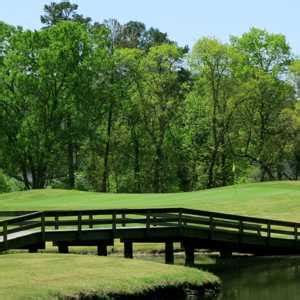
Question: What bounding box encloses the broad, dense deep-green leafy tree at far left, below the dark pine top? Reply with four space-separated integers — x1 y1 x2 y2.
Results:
0 22 103 188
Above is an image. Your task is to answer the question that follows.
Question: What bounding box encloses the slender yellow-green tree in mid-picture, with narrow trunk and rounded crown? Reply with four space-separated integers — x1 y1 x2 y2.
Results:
138 44 186 192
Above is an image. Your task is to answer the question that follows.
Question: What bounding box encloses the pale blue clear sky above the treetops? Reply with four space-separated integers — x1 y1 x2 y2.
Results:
0 0 300 55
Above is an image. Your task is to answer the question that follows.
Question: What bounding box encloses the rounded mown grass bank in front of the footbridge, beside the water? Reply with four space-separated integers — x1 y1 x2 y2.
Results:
0 254 219 300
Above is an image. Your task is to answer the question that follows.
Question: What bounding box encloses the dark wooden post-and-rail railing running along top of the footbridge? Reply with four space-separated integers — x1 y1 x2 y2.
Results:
0 208 300 242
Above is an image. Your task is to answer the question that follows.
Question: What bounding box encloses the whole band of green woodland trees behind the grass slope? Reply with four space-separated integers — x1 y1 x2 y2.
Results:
0 1 300 192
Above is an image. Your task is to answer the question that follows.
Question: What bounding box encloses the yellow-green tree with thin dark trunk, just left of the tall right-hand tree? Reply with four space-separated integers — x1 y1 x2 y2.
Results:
190 38 243 188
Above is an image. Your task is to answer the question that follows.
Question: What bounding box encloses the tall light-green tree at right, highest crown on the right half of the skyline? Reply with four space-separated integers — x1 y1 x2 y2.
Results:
231 28 294 181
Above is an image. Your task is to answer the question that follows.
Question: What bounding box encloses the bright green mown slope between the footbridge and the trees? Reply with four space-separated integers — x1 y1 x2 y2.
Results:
0 181 300 221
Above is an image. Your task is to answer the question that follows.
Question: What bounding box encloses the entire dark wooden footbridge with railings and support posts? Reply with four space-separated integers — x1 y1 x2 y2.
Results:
0 208 300 264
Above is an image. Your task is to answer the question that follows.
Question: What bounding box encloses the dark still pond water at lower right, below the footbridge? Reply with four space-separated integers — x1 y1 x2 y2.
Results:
139 256 300 300
